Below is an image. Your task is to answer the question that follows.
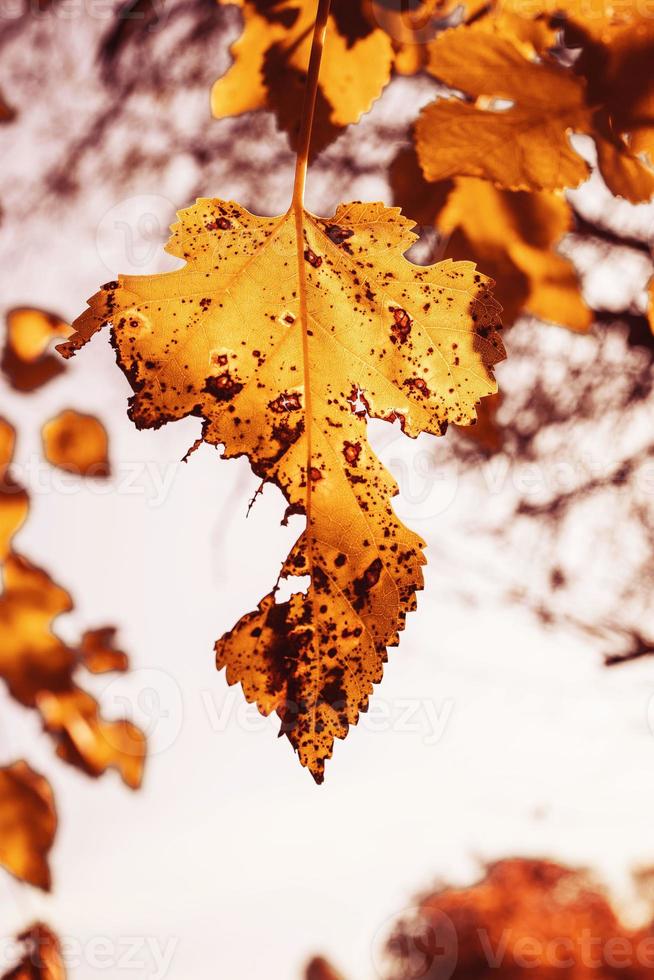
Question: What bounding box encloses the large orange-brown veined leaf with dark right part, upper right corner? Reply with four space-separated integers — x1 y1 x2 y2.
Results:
415 13 654 201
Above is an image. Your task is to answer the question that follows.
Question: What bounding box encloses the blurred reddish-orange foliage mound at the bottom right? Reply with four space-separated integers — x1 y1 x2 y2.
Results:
306 858 654 980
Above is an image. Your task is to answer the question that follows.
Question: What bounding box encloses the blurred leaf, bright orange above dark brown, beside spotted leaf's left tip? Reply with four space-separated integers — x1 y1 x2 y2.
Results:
1 307 71 392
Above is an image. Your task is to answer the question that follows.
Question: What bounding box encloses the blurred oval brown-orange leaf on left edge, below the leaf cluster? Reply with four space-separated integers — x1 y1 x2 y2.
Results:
0 761 57 891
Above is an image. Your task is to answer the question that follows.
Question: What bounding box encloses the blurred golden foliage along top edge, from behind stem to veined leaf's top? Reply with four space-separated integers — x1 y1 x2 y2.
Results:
211 0 490 151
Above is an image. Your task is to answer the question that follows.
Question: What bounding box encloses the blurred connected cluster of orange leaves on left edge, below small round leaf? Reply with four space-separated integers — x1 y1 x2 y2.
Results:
0 420 146 789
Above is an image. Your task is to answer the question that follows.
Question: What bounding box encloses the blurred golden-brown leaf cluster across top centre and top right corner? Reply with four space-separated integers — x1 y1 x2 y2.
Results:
217 0 654 330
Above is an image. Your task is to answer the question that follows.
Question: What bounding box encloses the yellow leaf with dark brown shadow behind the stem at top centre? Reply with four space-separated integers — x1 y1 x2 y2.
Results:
211 0 393 150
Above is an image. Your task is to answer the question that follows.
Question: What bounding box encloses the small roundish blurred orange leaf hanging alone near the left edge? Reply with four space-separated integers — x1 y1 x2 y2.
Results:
41 409 111 479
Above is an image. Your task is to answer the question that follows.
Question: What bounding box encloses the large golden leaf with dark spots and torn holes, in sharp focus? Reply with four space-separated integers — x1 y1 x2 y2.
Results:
60 200 504 781
